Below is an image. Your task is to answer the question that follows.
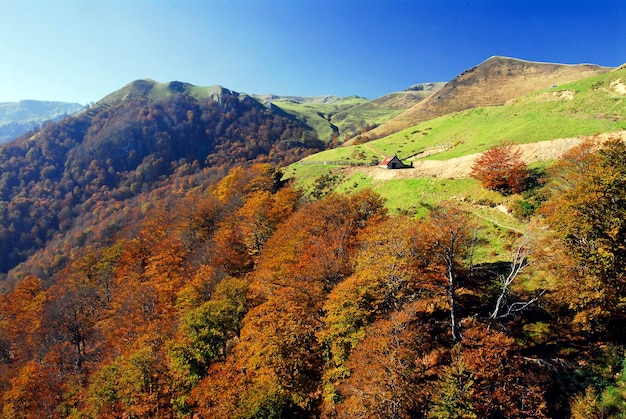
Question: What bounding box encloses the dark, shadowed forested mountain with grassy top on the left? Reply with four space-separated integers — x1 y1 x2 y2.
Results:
0 80 324 273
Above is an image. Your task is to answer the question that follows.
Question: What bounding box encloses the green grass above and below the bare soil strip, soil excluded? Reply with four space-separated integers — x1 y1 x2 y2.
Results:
286 68 626 236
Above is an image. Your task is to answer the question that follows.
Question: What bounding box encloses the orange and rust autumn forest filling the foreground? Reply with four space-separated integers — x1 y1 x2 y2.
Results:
0 136 626 418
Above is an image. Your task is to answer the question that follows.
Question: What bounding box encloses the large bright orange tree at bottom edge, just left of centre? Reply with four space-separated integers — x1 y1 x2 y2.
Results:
191 287 320 418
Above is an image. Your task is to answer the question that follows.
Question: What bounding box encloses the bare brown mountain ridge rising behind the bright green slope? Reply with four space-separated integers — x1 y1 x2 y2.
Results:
360 56 610 138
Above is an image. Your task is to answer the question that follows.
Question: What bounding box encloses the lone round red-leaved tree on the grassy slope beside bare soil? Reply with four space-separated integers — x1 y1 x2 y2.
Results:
471 145 528 193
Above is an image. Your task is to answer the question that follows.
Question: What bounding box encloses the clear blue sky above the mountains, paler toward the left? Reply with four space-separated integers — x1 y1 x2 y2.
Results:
0 0 626 104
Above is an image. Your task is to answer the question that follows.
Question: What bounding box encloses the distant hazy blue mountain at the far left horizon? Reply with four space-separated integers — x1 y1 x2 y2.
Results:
0 100 83 143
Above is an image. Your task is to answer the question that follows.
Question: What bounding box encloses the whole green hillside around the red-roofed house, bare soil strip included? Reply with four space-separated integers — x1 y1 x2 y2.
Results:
285 60 626 210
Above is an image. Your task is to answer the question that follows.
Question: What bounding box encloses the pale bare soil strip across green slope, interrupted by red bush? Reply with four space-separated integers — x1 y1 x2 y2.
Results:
351 131 626 180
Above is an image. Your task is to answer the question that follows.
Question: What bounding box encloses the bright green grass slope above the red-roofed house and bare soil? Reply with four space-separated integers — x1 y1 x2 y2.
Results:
294 68 626 167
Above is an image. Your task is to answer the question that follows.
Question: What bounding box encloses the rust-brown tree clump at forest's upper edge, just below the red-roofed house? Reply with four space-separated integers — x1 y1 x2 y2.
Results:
250 190 386 305
